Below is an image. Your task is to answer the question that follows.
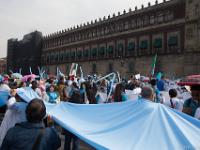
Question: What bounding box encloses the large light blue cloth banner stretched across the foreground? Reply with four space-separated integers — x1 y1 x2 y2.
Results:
0 89 200 150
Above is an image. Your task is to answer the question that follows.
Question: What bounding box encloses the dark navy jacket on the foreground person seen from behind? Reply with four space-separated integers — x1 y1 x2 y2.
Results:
0 122 61 150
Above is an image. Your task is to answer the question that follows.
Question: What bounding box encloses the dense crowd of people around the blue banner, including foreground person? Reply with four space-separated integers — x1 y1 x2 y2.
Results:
0 72 200 150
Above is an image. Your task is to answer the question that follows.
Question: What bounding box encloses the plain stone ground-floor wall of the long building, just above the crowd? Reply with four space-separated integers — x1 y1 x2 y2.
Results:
43 53 200 78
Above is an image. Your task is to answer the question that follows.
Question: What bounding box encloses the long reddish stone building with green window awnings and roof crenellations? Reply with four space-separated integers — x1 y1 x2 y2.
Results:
42 0 200 77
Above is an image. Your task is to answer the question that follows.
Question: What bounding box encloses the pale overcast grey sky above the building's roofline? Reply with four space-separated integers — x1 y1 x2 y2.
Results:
0 0 163 58
